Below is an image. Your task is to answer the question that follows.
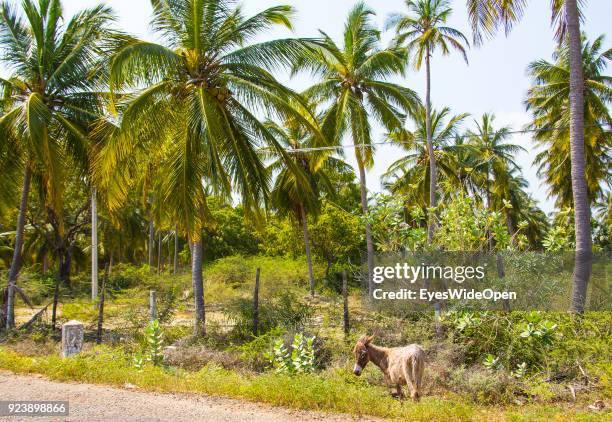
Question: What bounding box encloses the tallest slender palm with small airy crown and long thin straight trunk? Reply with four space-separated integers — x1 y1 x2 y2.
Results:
387 0 469 244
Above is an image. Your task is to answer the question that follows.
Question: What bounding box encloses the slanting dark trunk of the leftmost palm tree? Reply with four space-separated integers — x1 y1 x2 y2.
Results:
6 163 32 330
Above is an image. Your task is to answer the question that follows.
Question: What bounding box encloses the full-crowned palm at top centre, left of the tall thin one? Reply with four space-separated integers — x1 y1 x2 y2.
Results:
293 3 419 293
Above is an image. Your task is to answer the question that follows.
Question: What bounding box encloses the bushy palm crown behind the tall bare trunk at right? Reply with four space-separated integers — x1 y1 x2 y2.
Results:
526 36 612 209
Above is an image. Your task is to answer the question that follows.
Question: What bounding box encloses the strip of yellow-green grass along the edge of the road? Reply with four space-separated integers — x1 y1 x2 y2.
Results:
0 346 597 422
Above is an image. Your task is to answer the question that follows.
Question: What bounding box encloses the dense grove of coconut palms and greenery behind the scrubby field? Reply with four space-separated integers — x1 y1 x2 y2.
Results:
0 0 612 333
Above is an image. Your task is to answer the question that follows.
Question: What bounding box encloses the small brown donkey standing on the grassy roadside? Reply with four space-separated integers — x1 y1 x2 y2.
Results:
353 336 425 401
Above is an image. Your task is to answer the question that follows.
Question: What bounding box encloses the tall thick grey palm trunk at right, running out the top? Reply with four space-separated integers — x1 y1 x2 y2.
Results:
565 0 593 313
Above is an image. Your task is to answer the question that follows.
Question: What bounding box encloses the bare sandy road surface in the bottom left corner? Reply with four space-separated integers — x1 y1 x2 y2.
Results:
0 371 378 422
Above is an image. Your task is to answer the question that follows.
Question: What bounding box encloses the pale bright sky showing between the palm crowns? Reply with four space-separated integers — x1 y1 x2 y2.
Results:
2 0 612 212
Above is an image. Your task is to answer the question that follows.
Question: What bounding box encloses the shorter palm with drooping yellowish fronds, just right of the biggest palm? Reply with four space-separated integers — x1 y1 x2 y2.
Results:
266 107 346 296
